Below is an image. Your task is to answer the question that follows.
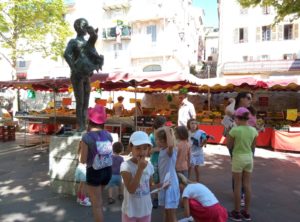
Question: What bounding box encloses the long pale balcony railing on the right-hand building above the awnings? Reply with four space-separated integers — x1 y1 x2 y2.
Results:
223 59 300 75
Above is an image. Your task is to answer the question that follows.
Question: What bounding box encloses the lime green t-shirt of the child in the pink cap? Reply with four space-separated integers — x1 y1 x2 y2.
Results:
229 126 258 155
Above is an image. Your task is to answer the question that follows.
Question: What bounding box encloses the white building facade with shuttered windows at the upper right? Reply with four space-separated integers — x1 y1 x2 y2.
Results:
217 0 300 77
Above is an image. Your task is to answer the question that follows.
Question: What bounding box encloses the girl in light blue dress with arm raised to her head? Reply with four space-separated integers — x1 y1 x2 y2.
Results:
155 126 180 222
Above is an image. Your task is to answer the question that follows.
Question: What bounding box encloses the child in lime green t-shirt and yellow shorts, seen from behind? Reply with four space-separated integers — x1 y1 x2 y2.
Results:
227 107 258 221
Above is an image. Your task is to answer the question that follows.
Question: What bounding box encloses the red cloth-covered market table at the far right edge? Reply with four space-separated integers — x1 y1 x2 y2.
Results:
272 130 300 152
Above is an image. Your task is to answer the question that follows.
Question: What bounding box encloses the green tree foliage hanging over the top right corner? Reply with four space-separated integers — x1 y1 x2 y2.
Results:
238 0 300 22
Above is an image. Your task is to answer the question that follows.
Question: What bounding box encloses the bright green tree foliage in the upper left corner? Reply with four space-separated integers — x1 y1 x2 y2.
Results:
0 0 71 68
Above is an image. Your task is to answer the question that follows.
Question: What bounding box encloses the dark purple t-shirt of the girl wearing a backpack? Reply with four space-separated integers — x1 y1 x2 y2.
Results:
82 130 113 167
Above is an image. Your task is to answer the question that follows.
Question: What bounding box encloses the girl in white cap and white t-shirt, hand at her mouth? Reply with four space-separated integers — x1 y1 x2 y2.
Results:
120 131 154 222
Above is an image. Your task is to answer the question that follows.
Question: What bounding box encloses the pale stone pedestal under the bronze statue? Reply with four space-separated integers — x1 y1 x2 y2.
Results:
49 136 81 195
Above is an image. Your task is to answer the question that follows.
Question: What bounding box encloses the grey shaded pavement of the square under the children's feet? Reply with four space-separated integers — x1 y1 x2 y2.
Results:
0 134 300 222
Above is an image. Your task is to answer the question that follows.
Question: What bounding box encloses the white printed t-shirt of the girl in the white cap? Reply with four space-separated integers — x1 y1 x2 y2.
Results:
120 160 154 217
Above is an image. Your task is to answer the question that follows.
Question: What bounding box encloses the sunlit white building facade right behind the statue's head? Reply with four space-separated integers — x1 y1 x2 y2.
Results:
101 0 203 72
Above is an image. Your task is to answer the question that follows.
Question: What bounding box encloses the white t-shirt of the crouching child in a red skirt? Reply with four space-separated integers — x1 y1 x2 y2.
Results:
182 183 219 207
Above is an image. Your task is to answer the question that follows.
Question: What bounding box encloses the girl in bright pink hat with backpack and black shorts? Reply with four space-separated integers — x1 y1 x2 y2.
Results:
80 105 113 221
